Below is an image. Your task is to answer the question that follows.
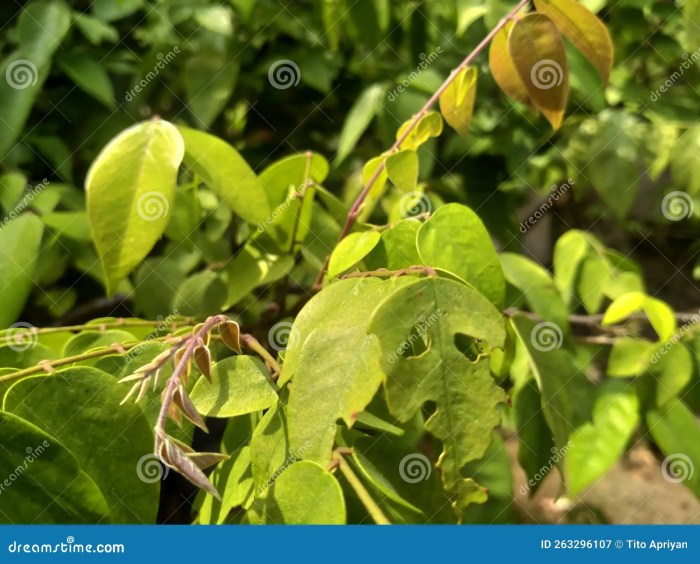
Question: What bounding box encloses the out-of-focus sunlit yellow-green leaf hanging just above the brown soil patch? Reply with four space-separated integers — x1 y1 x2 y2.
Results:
564 381 639 495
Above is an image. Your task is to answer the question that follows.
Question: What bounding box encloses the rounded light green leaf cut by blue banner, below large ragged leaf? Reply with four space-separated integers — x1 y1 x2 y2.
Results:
249 461 345 525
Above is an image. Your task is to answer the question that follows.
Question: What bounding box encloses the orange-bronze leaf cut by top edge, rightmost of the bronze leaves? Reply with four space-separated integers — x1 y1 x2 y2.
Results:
535 0 613 85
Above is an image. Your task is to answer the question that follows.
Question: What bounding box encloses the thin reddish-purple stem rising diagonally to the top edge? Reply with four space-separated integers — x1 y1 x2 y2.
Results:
314 0 530 289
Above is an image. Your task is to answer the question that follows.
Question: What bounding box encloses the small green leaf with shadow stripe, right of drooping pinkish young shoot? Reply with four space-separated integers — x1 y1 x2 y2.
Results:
190 356 277 417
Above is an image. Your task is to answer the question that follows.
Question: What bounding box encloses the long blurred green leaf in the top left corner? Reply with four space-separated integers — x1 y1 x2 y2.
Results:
0 0 70 159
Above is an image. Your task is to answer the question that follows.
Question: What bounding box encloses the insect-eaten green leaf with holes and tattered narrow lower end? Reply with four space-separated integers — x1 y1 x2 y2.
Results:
369 278 505 511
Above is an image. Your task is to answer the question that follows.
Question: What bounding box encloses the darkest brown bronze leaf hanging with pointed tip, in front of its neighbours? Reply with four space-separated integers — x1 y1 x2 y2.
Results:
508 13 569 129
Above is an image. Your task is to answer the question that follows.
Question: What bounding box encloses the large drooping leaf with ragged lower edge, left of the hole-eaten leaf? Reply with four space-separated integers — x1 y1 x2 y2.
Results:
280 276 410 464
